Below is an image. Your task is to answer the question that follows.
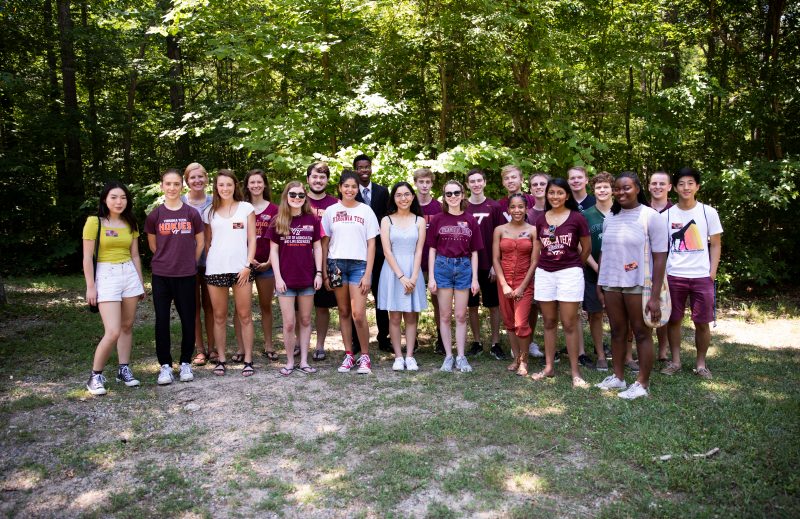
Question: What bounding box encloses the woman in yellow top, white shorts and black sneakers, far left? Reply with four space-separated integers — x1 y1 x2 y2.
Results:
83 181 145 395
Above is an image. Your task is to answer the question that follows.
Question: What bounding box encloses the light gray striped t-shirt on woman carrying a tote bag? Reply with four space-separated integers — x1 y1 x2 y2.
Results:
598 205 667 287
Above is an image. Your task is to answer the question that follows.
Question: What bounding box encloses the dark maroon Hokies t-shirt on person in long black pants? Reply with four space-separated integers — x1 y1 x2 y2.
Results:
144 204 205 277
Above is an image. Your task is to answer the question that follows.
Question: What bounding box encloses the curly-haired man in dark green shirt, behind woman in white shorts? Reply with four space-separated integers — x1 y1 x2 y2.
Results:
583 171 614 371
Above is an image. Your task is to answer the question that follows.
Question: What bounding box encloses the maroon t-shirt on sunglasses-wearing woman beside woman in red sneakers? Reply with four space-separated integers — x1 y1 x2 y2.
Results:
267 214 321 289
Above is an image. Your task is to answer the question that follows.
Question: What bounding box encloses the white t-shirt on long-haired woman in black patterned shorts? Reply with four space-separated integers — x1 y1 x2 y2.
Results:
203 202 255 274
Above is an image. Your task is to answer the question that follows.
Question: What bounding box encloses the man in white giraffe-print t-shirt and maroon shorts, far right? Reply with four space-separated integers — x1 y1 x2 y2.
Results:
661 168 722 379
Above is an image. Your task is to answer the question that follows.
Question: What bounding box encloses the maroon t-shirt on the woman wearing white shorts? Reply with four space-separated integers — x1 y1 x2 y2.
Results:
536 211 590 272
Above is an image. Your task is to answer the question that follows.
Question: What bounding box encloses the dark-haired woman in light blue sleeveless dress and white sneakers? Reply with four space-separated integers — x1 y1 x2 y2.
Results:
378 182 428 371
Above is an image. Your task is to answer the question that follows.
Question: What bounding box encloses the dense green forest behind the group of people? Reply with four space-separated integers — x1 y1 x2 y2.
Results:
0 0 800 291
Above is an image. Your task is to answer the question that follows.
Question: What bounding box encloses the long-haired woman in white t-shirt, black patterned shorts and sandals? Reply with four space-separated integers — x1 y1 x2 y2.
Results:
203 169 256 377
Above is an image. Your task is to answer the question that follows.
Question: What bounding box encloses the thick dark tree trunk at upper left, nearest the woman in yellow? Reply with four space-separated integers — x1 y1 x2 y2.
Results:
57 0 85 236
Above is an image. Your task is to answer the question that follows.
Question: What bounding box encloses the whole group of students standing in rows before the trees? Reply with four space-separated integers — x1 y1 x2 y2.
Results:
83 155 722 398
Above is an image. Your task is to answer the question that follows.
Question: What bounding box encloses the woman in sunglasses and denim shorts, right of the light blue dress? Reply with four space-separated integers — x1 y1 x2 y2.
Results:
426 180 483 373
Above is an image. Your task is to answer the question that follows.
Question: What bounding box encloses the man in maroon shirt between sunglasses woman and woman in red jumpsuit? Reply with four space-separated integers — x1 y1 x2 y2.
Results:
466 168 505 359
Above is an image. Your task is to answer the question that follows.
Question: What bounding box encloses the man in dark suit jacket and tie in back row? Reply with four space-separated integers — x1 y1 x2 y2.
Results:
353 154 394 351
